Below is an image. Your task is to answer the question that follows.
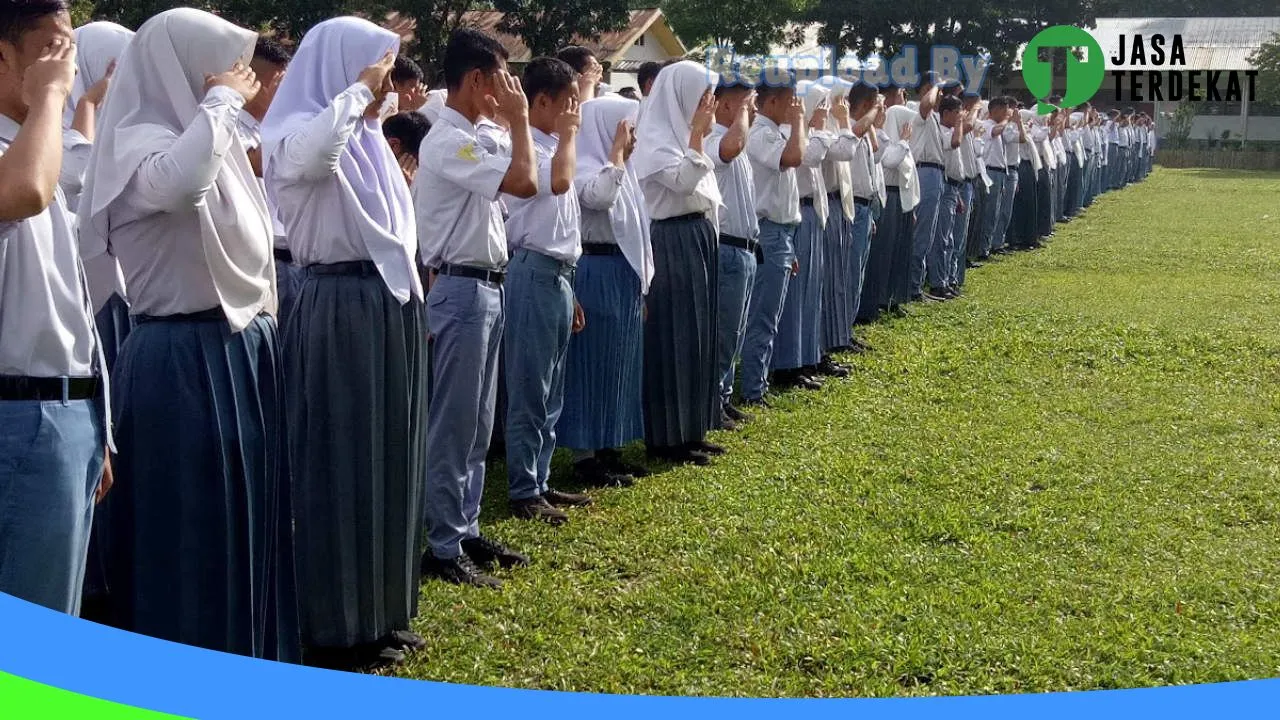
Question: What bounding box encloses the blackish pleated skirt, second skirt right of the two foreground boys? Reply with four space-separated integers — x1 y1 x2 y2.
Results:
644 214 719 447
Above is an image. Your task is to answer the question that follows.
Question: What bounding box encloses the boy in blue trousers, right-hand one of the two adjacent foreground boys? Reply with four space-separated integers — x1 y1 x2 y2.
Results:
503 58 591 525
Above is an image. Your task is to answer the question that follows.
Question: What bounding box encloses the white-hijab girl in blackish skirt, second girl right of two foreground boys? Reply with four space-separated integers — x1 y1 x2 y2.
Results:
632 60 723 465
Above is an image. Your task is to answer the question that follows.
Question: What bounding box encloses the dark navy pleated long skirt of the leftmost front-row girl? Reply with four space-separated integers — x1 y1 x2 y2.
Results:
108 313 300 661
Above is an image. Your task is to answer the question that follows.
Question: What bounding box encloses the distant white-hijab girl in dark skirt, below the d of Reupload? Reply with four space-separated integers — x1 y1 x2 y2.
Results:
876 101 920 311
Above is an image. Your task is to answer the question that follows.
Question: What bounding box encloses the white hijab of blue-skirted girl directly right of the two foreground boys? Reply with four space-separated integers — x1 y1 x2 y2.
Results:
575 95 653 292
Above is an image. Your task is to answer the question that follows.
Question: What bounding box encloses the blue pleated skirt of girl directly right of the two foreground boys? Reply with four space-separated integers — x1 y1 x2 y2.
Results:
556 255 644 450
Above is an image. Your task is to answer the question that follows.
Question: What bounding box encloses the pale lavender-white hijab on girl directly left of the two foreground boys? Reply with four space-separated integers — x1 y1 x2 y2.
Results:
262 18 422 305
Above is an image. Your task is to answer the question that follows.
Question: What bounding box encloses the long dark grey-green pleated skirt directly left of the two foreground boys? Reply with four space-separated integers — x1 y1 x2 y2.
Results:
284 263 428 648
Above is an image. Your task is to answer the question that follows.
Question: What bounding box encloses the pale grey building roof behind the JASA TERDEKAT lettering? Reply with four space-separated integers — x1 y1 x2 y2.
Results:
1091 17 1280 70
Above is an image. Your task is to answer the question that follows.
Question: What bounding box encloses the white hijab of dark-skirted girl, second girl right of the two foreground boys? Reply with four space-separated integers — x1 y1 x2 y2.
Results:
631 60 723 220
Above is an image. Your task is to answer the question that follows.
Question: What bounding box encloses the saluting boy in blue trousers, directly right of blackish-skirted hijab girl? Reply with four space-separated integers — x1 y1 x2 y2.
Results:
707 81 760 429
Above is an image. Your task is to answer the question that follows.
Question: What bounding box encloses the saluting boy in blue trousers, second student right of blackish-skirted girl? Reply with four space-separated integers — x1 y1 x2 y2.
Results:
741 77 809 405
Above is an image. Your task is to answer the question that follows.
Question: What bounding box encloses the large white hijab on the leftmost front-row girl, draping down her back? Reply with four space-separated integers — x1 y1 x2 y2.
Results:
79 8 275 332
